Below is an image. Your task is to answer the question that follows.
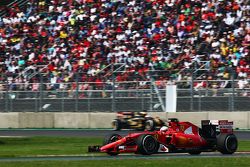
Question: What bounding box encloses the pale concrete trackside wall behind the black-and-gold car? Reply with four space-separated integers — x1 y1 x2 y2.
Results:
0 111 250 129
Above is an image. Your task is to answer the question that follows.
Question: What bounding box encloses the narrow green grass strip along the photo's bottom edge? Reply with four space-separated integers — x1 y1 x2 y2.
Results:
0 158 250 167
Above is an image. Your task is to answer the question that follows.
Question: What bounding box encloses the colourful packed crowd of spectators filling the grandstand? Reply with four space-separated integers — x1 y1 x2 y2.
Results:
0 0 250 94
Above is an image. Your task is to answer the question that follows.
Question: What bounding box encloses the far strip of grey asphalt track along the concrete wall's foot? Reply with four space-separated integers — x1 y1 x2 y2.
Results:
0 129 250 140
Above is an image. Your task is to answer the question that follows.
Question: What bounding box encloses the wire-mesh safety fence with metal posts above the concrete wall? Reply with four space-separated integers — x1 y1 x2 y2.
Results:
0 80 250 112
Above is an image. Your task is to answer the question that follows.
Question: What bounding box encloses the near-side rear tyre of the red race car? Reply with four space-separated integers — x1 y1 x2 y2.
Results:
217 134 238 154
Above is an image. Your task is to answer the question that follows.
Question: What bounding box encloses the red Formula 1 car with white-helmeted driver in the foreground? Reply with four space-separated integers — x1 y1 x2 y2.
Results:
89 119 238 155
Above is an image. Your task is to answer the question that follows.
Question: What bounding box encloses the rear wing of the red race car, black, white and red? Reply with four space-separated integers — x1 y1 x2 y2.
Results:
201 120 233 133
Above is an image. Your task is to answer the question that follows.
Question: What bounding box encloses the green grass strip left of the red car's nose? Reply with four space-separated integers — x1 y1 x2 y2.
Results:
0 137 102 157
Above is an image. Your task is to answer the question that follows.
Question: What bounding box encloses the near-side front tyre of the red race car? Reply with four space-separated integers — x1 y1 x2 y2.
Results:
136 134 159 155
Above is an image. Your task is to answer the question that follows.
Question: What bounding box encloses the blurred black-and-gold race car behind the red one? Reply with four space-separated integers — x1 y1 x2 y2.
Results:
111 112 165 131
